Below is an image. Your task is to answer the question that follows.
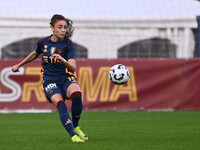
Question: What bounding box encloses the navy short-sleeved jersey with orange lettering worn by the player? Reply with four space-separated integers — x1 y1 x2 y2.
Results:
36 36 76 79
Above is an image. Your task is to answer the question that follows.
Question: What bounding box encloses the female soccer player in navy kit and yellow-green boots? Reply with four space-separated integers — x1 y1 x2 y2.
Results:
12 14 88 142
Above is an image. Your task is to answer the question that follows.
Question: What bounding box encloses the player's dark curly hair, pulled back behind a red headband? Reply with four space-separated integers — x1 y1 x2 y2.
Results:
49 14 74 38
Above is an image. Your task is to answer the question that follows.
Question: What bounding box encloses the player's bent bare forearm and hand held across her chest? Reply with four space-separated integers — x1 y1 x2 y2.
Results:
51 53 76 73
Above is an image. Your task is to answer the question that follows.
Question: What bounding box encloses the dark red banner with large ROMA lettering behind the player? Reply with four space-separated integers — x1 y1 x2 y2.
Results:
0 58 200 110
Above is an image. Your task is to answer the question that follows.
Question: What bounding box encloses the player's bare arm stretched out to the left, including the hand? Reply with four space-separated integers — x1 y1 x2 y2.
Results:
12 51 40 72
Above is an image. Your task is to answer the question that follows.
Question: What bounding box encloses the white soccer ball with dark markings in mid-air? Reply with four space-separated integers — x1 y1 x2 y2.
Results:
109 64 130 85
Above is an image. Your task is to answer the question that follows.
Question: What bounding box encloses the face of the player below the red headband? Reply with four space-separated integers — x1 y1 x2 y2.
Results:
51 21 67 39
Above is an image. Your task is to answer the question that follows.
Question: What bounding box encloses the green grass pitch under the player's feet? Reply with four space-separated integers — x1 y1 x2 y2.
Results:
0 111 200 150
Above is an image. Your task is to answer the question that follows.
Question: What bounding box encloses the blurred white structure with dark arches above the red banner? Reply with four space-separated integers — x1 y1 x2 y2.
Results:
0 0 200 58
